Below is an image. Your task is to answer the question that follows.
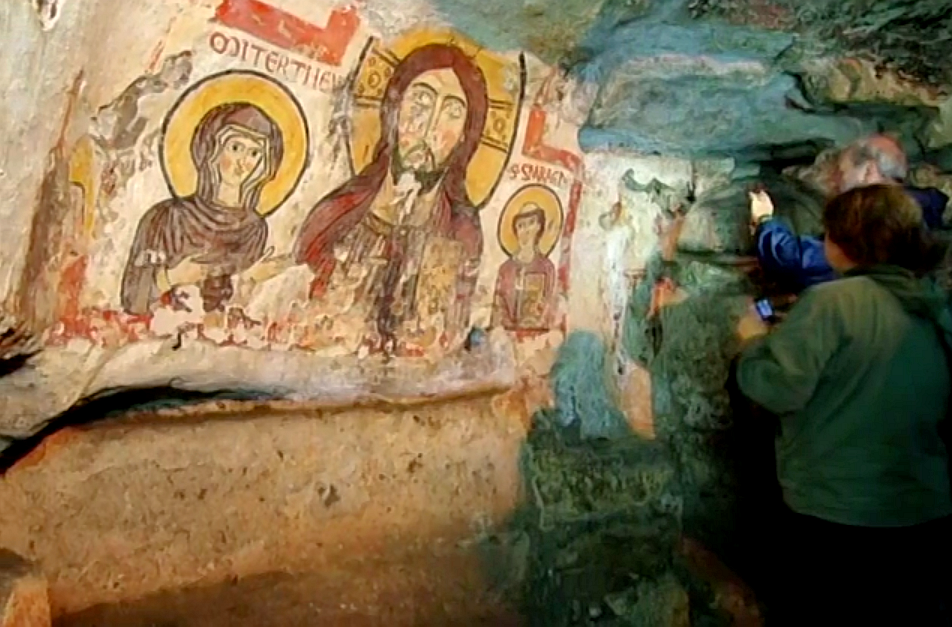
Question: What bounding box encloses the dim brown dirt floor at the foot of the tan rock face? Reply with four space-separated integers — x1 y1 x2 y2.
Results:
54 555 524 627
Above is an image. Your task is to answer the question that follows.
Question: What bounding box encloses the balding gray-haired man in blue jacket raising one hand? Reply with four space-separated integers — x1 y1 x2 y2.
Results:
750 135 949 292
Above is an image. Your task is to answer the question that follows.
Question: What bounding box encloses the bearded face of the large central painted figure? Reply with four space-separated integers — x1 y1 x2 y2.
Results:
397 69 469 172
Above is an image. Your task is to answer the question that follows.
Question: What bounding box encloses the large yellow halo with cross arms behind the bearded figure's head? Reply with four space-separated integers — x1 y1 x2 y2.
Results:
349 30 525 207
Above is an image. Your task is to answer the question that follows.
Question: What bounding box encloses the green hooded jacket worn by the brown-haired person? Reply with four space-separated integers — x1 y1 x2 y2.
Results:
737 266 952 527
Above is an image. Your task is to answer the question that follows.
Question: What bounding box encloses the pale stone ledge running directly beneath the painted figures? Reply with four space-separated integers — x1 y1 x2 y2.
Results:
0 330 517 451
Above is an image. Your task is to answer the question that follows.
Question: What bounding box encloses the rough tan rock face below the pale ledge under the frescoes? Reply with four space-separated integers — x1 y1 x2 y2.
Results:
0 396 527 625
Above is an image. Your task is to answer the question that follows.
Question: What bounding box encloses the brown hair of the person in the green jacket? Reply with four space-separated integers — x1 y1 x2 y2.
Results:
823 185 944 274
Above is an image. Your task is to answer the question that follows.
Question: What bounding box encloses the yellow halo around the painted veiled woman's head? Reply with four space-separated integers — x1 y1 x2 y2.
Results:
159 70 309 215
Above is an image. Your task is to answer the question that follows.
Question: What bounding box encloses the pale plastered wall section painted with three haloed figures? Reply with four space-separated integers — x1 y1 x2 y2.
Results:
0 0 744 446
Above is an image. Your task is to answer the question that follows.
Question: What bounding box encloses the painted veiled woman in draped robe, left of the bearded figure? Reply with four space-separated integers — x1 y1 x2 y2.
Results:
122 102 284 314
